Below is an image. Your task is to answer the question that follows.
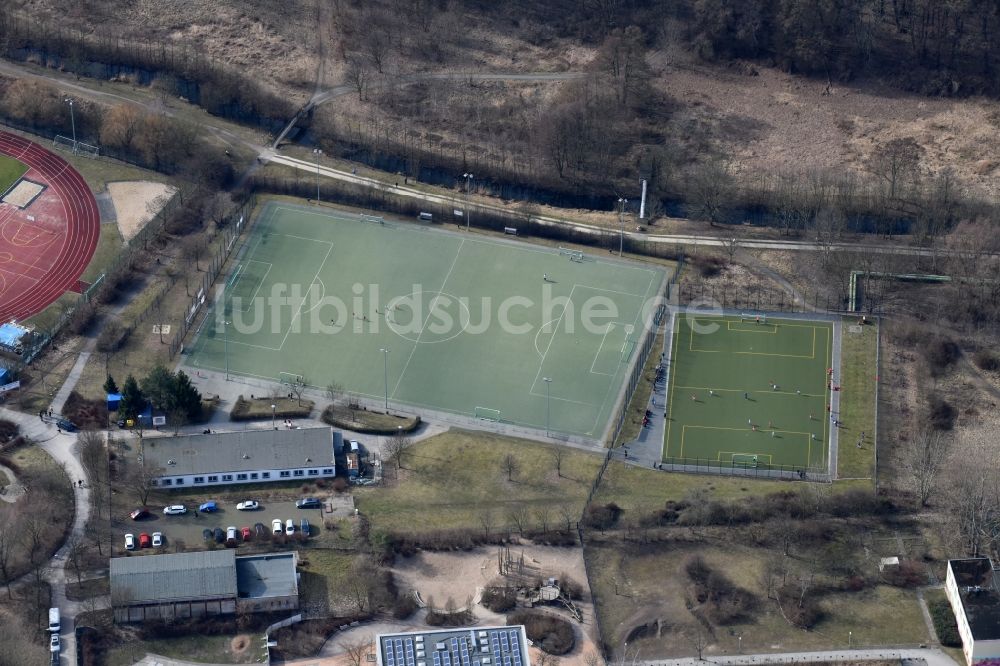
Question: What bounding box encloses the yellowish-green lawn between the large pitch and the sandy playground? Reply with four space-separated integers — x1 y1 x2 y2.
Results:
355 430 602 533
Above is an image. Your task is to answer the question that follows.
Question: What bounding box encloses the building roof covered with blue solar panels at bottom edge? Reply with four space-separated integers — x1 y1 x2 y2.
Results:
376 624 531 666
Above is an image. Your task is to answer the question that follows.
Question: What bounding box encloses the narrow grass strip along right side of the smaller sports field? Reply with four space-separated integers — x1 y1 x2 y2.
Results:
837 317 879 479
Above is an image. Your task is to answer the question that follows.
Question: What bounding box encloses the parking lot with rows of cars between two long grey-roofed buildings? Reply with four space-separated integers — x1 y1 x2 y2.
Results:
112 496 324 556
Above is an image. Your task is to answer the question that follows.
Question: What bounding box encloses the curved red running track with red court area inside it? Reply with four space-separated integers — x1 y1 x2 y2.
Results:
0 132 101 323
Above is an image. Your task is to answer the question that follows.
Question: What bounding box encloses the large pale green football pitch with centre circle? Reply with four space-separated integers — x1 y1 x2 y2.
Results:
188 203 666 438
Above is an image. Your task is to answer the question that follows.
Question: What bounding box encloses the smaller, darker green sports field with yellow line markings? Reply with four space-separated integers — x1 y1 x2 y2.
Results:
663 313 834 471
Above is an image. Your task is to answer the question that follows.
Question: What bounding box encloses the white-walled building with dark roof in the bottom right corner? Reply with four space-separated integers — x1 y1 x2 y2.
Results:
945 557 1000 666
